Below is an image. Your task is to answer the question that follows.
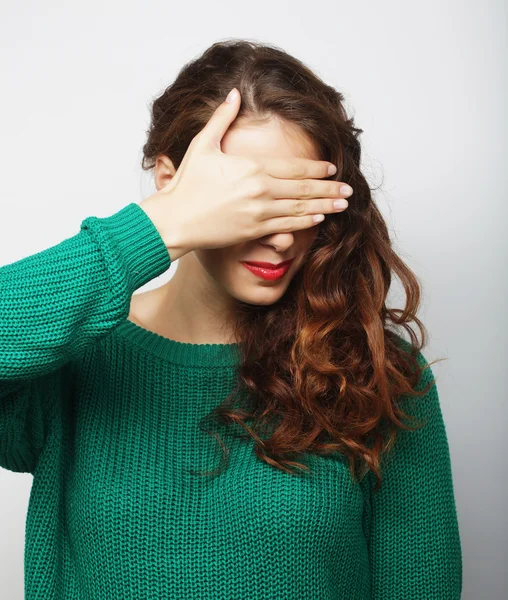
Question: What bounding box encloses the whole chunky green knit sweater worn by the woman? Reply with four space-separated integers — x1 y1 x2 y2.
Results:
0 203 462 600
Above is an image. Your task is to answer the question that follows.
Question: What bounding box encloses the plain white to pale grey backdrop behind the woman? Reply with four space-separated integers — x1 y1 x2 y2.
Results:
0 0 508 600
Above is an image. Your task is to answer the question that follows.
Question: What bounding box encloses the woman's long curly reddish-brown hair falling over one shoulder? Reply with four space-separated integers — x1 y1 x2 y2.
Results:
142 38 444 489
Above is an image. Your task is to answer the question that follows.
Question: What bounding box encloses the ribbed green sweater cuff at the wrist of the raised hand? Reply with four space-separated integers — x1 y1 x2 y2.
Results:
98 202 171 291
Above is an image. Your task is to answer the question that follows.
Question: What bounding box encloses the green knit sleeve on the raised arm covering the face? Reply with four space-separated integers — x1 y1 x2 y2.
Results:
0 203 171 472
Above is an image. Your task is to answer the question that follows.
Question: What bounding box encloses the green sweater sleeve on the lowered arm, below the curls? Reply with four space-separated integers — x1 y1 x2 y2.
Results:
369 352 462 600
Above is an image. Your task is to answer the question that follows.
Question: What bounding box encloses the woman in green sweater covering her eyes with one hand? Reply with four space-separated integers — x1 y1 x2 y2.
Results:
0 40 462 600
